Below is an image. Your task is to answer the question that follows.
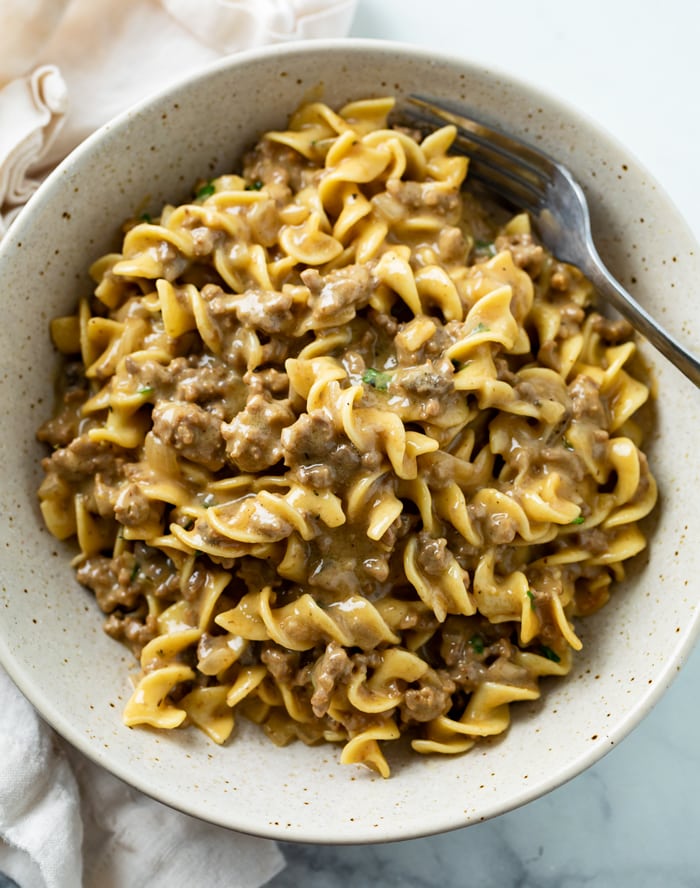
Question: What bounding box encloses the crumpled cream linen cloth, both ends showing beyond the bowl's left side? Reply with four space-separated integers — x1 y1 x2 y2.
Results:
0 0 355 888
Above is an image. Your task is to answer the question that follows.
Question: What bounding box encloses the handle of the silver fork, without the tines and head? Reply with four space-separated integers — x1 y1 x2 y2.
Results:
584 245 700 387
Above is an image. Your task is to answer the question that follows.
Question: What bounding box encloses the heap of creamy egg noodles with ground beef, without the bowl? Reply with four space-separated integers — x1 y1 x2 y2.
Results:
39 98 656 776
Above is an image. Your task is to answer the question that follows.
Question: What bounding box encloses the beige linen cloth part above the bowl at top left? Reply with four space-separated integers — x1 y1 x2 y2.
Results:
0 0 356 236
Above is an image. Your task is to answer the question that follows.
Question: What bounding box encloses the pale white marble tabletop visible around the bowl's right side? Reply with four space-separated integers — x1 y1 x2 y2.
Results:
269 0 700 888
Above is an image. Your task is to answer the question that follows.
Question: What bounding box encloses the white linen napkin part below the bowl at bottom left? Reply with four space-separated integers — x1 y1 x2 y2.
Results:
0 669 284 888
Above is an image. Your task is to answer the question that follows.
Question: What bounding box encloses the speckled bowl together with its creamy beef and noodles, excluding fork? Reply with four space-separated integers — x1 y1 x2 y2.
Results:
0 40 700 842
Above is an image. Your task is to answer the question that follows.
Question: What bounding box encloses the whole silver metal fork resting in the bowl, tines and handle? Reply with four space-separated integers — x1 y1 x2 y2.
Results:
401 95 700 386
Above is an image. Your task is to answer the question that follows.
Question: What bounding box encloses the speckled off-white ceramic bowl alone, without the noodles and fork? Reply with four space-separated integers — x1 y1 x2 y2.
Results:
0 41 700 842
